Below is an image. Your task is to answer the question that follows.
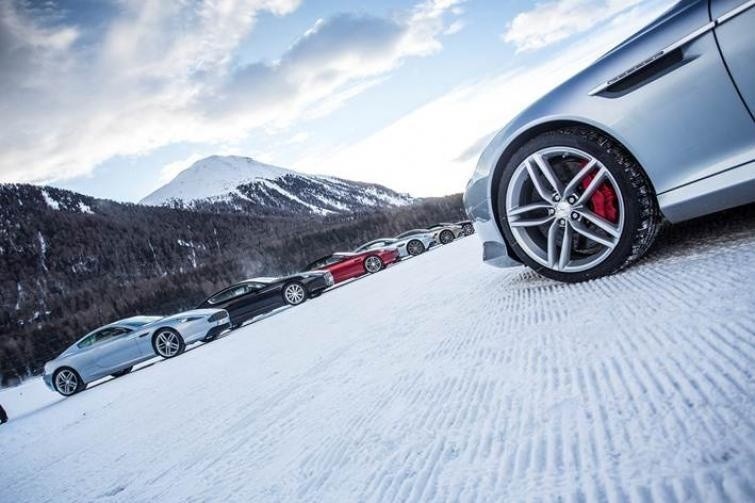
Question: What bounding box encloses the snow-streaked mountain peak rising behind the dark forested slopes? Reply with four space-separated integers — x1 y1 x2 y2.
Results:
141 156 413 215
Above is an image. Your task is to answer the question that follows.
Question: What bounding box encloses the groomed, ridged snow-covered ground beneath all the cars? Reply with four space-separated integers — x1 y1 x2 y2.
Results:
0 211 755 502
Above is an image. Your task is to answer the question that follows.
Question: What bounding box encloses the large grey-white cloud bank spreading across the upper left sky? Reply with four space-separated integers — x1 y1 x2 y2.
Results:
0 0 461 186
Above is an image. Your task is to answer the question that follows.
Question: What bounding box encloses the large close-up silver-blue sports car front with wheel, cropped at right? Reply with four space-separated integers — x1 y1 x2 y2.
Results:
464 0 755 281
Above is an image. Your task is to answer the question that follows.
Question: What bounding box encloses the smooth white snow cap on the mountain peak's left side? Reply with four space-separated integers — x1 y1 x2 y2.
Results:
141 156 296 206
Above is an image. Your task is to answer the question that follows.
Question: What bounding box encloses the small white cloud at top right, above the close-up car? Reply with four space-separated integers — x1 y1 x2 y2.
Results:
502 0 643 52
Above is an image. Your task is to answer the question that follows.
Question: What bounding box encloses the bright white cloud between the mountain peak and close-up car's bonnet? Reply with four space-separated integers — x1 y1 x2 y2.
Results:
294 2 662 196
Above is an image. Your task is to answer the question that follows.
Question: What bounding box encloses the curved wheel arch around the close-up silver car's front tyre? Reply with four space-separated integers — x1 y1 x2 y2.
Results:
488 119 657 252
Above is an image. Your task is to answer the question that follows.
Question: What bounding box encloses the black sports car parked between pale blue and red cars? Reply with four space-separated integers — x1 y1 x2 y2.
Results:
198 271 334 328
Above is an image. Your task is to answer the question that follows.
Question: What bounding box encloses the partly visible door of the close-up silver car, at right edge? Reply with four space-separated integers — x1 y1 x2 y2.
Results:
710 0 755 120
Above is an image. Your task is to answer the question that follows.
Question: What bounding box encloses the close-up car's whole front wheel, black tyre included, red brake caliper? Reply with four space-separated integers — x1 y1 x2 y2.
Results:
497 128 660 282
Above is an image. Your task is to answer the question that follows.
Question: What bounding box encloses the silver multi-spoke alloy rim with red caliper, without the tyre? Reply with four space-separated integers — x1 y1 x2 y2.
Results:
506 147 624 272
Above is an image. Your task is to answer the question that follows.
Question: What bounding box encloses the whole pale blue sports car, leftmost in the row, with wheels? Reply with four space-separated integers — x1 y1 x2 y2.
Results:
43 309 230 396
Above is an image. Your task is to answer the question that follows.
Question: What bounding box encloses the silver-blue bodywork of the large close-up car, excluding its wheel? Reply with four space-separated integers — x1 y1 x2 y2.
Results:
464 0 755 267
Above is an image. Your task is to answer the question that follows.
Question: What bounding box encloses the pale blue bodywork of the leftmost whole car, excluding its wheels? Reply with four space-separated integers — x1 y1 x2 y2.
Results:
43 309 229 390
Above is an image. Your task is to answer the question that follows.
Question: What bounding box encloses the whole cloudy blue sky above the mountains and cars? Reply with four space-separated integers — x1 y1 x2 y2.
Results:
0 0 673 202
